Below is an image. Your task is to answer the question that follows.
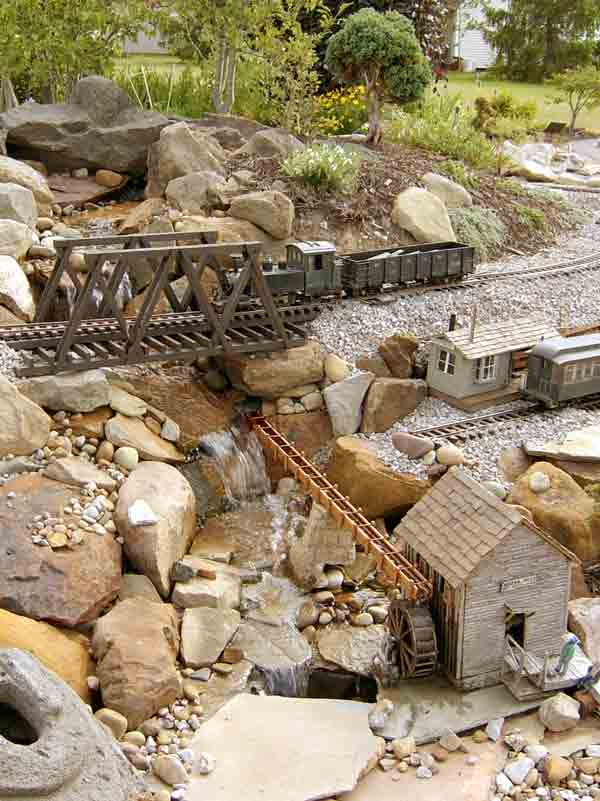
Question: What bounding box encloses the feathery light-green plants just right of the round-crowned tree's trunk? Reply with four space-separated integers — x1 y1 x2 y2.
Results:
388 95 495 168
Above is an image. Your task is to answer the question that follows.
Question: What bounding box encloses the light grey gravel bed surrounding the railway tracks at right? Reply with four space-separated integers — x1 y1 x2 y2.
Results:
313 192 600 481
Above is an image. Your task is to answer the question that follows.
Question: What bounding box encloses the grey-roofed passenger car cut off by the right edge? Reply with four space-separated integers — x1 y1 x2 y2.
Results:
524 334 600 408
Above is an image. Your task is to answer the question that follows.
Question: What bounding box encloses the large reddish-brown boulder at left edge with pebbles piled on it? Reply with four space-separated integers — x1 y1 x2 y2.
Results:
0 474 122 628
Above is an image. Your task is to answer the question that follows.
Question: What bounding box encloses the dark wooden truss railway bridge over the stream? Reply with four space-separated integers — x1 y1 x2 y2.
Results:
0 232 319 376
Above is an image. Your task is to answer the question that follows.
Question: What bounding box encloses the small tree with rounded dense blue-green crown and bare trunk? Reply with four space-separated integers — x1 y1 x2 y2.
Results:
325 9 432 144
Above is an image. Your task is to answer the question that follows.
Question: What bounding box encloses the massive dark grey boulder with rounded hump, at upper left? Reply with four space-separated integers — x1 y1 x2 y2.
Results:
0 75 169 174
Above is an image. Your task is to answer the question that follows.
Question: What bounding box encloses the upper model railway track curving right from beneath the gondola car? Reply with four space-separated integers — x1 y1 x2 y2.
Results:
358 252 600 305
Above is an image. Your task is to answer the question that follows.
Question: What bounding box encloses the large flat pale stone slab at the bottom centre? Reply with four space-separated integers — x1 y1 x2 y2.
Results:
187 694 378 801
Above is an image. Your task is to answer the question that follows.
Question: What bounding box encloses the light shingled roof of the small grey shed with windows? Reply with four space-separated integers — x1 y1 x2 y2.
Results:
442 317 558 359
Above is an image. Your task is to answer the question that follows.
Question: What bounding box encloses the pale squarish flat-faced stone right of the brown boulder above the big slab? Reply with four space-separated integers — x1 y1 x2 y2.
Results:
181 606 241 668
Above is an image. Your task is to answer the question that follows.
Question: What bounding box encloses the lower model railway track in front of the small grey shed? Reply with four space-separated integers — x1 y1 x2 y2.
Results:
409 393 600 443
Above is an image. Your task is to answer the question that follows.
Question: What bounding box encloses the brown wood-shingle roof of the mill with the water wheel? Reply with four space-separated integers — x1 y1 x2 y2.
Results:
394 467 578 587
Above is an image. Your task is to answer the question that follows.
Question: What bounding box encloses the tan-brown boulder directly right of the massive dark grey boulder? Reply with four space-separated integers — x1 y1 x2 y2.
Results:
146 122 227 197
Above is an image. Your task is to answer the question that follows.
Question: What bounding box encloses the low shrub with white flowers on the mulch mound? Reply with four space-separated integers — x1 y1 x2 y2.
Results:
281 145 361 192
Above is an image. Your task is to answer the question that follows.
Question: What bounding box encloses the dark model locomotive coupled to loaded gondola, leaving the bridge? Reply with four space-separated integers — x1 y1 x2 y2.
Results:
230 242 475 304
